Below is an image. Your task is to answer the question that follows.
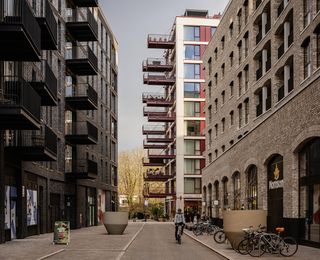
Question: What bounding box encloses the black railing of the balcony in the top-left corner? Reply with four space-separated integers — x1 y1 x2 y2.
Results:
0 0 41 52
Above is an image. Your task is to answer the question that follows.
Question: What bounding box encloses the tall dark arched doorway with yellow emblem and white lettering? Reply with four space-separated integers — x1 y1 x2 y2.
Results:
268 154 283 232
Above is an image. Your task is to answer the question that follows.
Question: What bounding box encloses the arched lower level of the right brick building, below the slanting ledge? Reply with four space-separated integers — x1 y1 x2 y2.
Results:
202 80 320 247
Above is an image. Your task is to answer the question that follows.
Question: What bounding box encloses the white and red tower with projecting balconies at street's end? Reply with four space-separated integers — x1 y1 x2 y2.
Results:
143 10 219 216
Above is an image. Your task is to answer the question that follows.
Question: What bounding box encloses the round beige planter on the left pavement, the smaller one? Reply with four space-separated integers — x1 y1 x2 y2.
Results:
103 211 129 235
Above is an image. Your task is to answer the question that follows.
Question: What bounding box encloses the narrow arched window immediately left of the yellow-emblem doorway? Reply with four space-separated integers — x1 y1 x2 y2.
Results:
247 165 258 209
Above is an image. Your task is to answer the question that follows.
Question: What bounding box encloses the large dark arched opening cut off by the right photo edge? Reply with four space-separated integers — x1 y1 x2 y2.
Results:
299 138 320 246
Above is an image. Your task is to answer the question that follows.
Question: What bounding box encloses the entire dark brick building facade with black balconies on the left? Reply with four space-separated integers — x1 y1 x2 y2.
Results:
0 0 118 242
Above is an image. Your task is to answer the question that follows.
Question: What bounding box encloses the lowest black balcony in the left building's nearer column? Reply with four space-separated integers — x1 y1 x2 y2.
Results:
5 126 57 161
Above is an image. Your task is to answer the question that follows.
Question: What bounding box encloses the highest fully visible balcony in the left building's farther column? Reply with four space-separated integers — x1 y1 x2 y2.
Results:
66 9 98 42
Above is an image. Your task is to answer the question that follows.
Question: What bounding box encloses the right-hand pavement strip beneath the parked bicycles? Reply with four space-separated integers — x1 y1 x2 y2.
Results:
184 229 320 260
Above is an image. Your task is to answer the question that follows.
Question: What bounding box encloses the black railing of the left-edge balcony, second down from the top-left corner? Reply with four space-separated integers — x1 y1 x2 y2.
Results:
0 76 41 121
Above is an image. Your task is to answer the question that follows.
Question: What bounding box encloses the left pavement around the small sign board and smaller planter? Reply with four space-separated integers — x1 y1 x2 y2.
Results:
0 222 144 260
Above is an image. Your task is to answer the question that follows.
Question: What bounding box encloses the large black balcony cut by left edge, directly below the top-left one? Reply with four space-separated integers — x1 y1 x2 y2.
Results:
0 76 41 130
